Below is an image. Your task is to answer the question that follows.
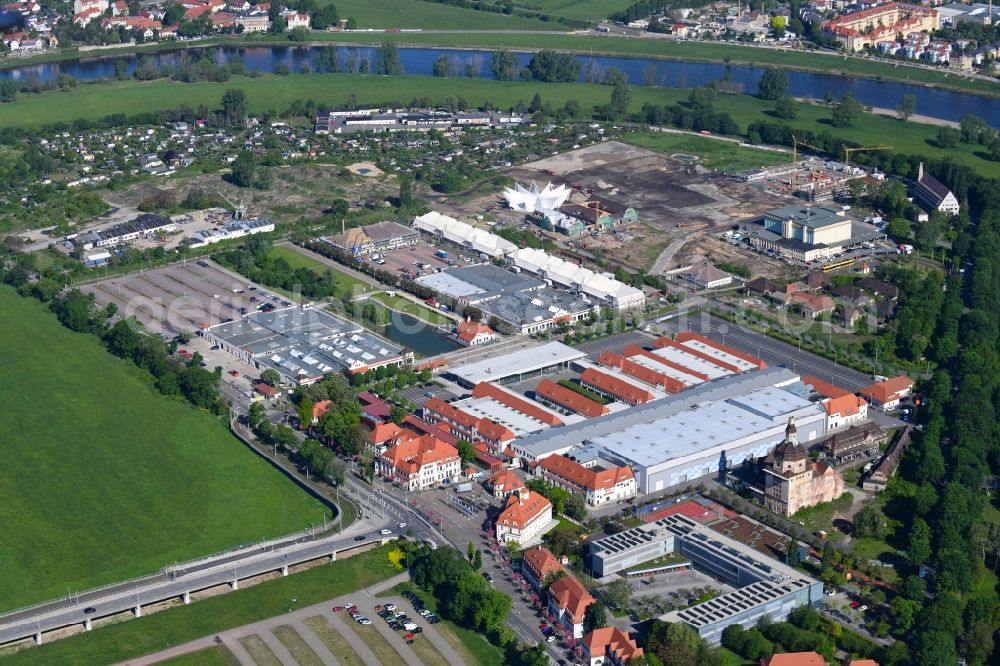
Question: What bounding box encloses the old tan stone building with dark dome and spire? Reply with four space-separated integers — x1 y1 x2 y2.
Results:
764 418 844 517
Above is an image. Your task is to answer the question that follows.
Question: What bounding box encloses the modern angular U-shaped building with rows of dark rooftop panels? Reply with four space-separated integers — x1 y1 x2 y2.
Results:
587 514 823 645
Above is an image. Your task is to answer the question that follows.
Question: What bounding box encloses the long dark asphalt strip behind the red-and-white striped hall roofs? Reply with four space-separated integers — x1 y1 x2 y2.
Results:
651 312 873 391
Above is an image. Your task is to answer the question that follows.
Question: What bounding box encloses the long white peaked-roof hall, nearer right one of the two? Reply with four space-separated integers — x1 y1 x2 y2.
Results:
507 247 646 310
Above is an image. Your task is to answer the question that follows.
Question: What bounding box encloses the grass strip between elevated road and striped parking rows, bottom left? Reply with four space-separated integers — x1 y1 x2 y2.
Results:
3 547 399 666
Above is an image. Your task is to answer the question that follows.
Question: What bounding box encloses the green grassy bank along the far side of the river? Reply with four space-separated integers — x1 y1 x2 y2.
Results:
0 30 1000 99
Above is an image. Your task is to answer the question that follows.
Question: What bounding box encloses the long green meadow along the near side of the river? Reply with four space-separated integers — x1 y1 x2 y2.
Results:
0 74 1000 177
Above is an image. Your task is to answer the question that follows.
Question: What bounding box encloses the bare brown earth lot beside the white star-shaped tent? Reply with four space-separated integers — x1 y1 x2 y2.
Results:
500 141 782 272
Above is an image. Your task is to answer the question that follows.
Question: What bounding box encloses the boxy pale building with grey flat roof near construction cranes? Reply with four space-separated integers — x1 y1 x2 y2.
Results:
740 204 885 262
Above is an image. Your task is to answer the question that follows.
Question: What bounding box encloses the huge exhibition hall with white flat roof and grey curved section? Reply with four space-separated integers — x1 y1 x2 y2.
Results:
513 368 826 493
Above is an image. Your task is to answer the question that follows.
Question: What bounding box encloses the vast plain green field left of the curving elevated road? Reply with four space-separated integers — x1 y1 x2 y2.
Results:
0 287 323 609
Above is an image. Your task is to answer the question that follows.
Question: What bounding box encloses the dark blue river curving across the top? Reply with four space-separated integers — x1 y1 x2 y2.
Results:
0 45 1000 127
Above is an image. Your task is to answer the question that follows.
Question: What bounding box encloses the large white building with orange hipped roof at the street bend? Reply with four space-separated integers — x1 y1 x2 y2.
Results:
376 435 460 490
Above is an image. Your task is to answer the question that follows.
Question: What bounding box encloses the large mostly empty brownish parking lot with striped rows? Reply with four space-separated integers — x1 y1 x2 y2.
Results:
82 261 289 337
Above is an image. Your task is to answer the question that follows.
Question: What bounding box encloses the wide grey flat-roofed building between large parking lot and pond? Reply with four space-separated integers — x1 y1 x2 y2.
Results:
201 306 413 385
